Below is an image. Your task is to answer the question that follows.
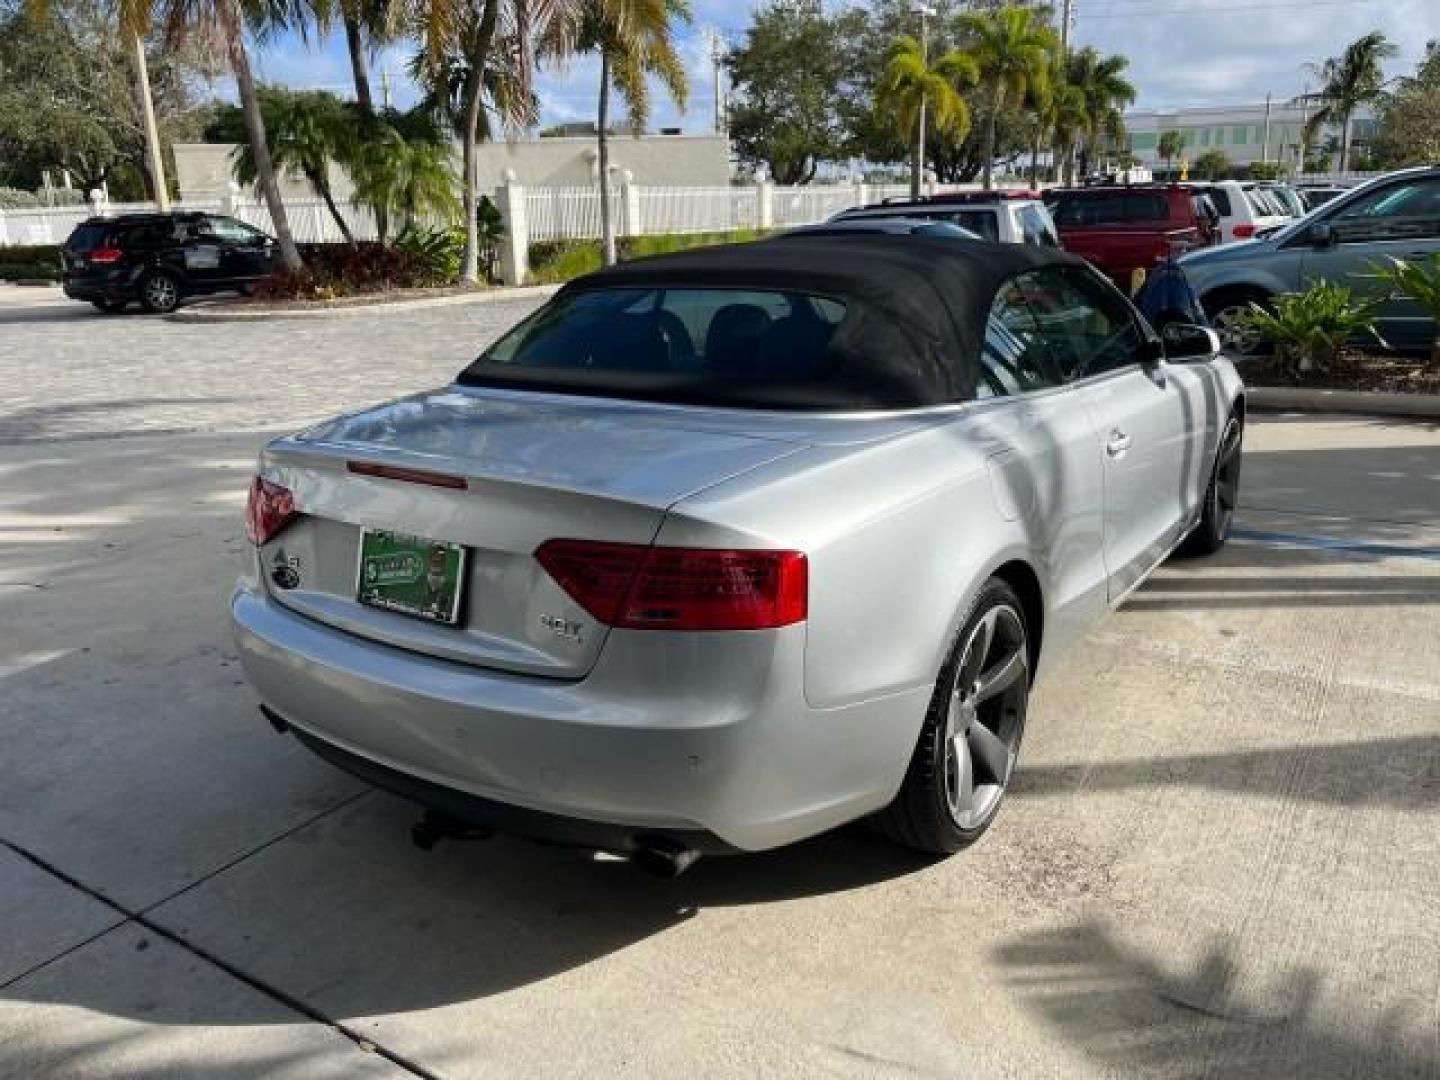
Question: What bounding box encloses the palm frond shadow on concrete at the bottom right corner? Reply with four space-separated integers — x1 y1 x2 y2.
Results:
995 922 1440 1080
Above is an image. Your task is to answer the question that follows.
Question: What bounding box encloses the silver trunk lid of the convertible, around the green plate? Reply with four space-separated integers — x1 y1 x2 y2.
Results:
259 389 806 678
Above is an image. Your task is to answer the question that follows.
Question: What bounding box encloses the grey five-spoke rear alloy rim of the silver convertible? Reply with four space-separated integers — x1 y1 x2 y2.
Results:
943 603 1030 831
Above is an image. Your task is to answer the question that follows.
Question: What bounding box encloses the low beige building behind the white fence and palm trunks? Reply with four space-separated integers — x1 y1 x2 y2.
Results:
174 135 730 200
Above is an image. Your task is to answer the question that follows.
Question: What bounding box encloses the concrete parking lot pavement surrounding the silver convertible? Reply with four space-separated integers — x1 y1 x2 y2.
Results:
0 292 1440 1080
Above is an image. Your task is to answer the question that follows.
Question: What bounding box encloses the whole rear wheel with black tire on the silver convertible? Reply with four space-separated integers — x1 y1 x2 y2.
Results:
876 577 1030 855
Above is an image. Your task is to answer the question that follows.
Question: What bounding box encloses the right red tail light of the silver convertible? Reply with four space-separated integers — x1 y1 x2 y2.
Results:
536 540 809 631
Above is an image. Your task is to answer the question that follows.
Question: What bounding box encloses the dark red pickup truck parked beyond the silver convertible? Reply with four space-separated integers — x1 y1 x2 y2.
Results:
1045 184 1220 292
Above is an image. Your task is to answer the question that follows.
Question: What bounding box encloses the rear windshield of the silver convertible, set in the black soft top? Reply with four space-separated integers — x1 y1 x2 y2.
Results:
459 287 933 409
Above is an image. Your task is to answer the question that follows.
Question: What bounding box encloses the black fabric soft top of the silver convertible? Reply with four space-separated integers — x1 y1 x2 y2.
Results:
459 235 1083 409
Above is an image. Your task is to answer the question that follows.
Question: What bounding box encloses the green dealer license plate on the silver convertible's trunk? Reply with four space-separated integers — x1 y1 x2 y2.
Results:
356 528 465 625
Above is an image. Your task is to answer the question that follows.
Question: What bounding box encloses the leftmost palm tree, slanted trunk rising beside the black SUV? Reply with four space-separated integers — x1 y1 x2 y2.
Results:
148 0 304 271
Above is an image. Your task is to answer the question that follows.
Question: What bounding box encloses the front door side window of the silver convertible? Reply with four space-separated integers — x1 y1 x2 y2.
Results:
1024 266 1145 383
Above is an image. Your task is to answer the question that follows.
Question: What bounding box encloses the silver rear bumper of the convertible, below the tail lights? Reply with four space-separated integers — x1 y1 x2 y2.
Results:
232 582 929 850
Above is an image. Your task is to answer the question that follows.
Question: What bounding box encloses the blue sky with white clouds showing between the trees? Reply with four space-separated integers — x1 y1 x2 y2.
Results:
256 0 1440 131
